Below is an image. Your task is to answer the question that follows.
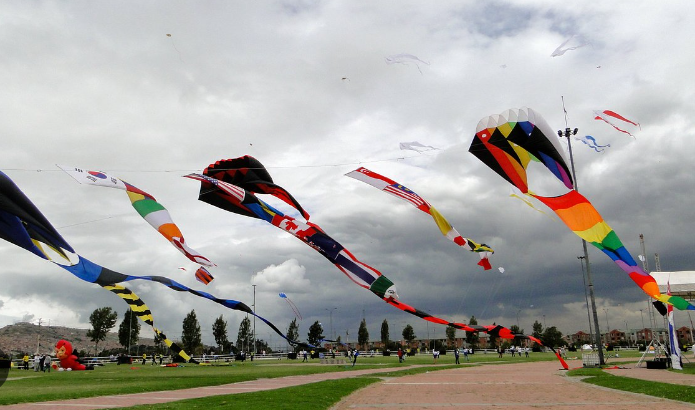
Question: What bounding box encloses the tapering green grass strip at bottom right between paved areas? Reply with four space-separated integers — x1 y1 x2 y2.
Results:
567 368 695 403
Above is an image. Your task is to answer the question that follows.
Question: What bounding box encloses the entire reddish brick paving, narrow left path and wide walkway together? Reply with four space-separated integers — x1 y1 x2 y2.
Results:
3 360 695 410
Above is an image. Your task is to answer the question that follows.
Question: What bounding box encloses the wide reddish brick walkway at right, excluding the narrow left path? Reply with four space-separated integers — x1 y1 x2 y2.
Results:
331 360 695 410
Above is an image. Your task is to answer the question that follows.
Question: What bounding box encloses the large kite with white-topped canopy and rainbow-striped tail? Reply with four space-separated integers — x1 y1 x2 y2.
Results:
469 108 695 310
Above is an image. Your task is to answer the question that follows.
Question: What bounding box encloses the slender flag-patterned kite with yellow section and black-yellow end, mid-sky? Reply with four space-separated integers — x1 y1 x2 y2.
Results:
345 167 494 270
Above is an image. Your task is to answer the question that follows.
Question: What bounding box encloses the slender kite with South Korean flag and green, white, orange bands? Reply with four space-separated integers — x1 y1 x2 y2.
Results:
58 165 215 266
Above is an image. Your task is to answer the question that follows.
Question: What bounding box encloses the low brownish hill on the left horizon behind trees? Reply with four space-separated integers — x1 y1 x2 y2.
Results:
0 322 154 356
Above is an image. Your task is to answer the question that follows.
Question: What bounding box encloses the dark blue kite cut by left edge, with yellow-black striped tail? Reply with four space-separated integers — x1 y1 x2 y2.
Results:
0 171 312 361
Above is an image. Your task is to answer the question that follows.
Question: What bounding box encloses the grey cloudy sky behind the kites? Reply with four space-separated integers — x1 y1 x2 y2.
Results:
0 0 695 346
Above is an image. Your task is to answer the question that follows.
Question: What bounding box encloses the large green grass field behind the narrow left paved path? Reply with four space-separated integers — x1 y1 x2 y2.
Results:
0 353 557 408
